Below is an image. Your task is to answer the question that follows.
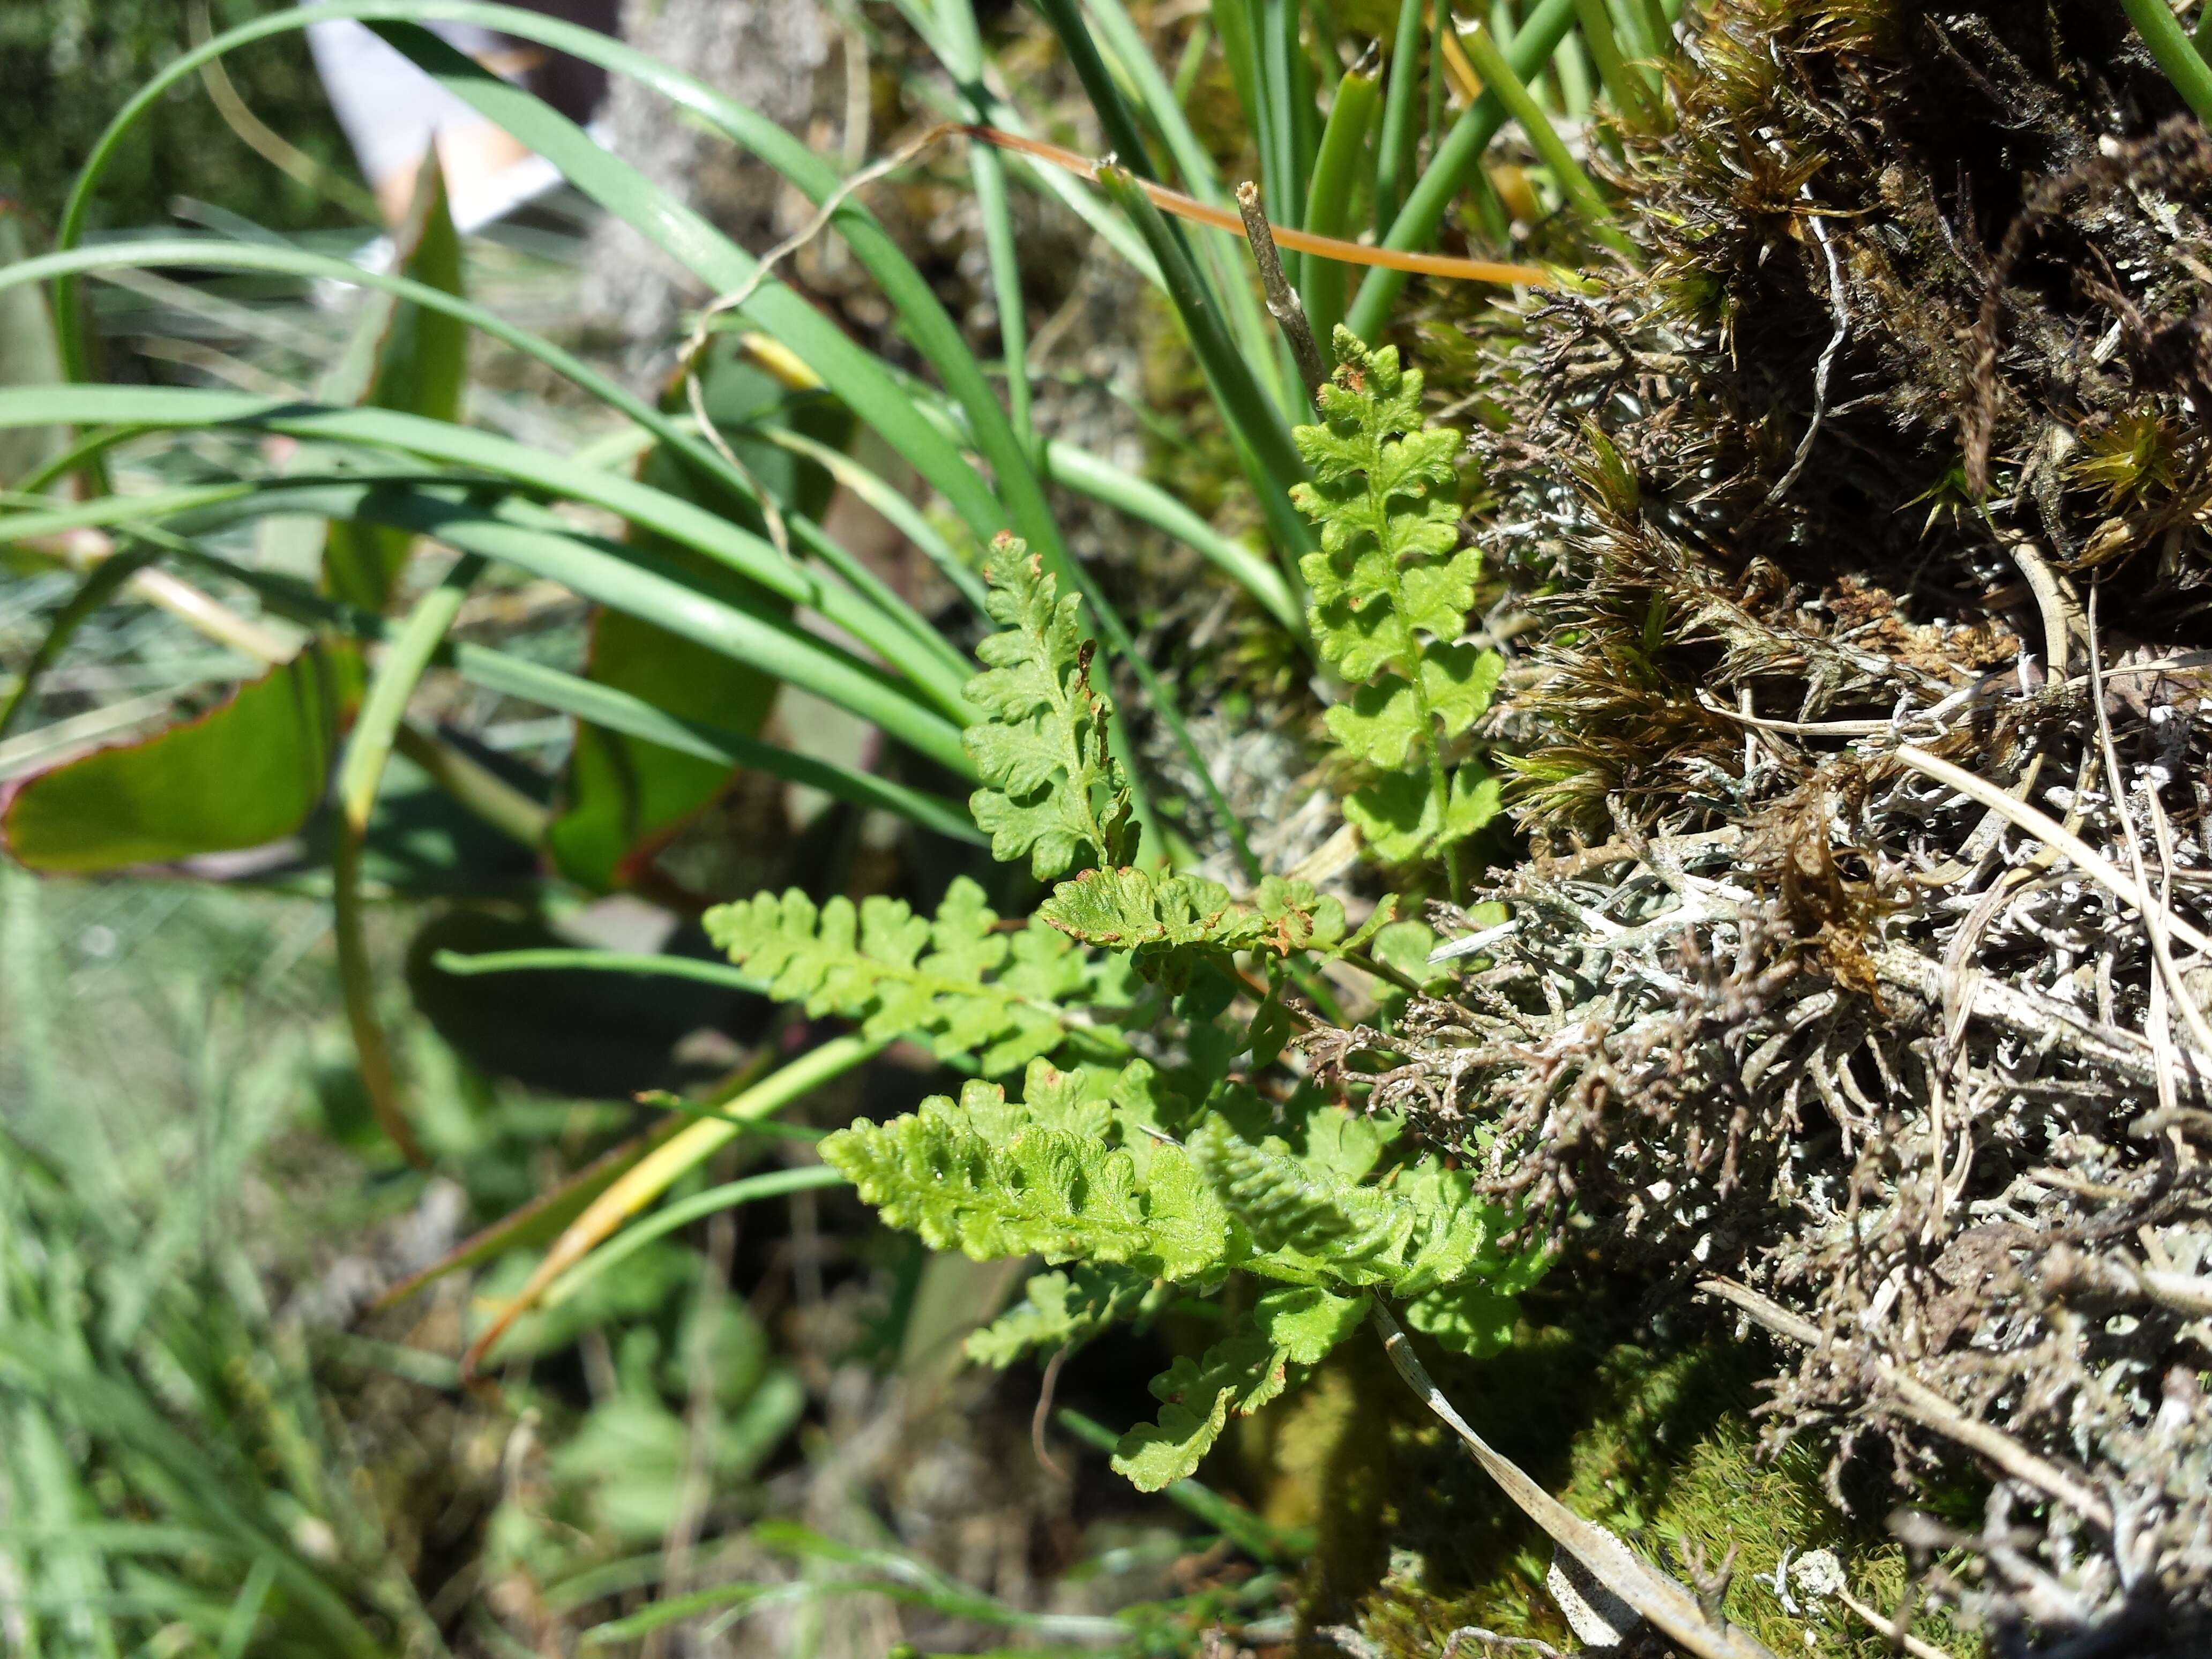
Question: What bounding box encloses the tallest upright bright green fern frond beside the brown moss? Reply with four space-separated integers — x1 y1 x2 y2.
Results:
1292 330 1500 863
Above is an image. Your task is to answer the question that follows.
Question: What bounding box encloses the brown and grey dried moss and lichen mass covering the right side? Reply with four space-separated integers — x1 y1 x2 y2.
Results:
1316 0 2212 1655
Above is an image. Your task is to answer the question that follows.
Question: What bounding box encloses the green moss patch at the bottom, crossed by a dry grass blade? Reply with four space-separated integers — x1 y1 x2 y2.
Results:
1245 1320 1980 1659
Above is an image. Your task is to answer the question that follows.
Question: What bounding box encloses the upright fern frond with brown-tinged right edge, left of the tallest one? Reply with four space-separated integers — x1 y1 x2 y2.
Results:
960 535 1135 880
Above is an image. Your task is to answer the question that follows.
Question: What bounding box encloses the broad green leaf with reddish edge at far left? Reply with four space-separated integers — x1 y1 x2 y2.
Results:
0 648 361 876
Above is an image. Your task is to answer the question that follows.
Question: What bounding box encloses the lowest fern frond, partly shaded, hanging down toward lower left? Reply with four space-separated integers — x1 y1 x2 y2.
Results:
1112 1285 1367 1491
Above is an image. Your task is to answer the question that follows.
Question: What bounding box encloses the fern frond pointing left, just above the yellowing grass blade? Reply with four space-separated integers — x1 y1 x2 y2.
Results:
706 876 1086 1075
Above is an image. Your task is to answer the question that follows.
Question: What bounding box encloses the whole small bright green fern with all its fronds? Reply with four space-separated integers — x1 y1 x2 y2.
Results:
708 347 1544 1491
